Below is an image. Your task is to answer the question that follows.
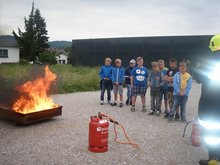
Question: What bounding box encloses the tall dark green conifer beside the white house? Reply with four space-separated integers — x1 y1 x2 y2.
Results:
12 3 49 61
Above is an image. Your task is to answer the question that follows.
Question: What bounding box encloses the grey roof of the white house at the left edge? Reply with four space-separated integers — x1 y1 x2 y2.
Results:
0 35 19 47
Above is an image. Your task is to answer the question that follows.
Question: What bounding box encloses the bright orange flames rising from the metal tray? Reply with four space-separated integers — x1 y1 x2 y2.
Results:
12 66 58 114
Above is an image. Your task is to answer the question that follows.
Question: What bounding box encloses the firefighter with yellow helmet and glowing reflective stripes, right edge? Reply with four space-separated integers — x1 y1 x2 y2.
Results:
195 34 220 164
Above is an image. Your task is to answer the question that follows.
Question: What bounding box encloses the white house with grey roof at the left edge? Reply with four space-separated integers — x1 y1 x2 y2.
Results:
0 35 20 64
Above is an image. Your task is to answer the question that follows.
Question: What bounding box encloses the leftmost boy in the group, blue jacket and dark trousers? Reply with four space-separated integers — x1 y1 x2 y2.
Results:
99 58 112 105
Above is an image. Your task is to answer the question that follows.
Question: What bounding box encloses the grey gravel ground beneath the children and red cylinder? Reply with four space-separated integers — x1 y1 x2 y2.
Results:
0 83 207 165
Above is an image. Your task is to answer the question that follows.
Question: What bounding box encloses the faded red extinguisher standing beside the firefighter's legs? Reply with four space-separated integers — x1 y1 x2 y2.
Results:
191 122 202 146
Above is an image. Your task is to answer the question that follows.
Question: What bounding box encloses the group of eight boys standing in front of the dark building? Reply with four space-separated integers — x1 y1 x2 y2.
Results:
99 57 192 122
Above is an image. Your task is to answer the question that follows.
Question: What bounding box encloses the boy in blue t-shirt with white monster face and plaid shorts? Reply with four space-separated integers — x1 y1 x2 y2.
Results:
131 57 148 112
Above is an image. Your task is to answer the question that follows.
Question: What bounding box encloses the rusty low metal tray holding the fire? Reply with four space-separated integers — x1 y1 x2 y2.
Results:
0 106 62 125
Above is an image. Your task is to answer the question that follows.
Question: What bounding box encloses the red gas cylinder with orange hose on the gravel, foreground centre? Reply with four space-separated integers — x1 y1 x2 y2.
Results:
88 116 109 152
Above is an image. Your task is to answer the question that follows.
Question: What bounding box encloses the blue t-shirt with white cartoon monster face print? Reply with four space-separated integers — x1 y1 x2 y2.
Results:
131 66 148 87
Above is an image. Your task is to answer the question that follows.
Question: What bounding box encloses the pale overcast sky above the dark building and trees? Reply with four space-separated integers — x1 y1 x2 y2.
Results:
0 0 220 41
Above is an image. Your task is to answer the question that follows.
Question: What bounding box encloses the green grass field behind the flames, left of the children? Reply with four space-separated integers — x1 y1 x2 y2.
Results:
0 64 99 93
